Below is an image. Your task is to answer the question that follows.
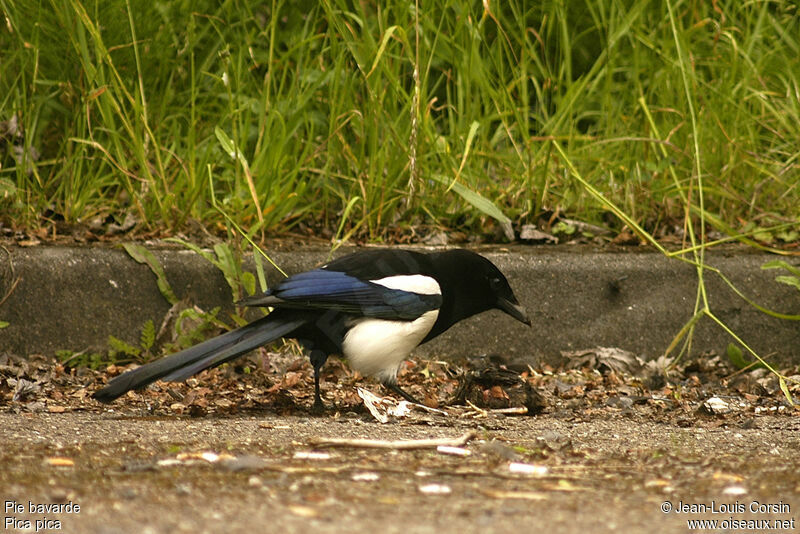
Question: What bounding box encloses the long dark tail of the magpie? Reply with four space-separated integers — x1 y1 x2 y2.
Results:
92 314 305 402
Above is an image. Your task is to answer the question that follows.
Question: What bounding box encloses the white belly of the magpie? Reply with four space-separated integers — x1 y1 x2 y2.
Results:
342 310 439 384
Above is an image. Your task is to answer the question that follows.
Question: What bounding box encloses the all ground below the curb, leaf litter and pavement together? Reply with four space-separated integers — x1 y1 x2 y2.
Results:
0 352 800 534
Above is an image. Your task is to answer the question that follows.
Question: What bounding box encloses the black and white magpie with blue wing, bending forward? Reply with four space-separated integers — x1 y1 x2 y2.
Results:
93 249 531 412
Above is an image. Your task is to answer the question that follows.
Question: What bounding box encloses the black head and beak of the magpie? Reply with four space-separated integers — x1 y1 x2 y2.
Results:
433 249 531 326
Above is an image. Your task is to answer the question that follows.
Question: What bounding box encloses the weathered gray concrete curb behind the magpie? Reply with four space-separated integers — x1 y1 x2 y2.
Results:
0 246 800 362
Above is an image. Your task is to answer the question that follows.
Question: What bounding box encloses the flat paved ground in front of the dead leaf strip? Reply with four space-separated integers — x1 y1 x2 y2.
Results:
0 412 800 534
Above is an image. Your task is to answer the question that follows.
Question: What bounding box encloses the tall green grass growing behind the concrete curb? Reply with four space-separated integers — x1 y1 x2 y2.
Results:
0 0 800 242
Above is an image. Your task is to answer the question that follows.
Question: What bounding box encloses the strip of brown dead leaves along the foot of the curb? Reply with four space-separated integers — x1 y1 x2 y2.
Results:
0 348 800 426
